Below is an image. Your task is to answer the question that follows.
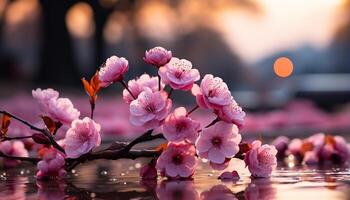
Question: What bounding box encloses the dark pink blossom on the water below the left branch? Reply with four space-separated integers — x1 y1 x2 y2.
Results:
36 148 66 179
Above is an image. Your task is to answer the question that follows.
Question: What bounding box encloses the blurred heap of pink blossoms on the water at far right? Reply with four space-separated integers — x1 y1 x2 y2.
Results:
272 133 350 165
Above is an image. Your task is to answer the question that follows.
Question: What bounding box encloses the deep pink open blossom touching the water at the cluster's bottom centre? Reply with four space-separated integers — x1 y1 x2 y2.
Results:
156 143 197 179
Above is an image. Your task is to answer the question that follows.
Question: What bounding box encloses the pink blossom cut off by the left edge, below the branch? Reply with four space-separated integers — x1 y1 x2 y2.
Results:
0 140 28 167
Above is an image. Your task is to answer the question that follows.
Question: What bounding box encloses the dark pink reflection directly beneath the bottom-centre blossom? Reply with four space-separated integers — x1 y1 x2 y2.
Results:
156 180 200 200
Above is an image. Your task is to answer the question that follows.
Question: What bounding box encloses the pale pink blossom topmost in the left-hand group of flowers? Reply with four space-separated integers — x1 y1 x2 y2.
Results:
32 88 59 113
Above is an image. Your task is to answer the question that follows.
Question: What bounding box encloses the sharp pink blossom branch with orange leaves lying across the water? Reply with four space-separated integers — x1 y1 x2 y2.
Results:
0 47 277 179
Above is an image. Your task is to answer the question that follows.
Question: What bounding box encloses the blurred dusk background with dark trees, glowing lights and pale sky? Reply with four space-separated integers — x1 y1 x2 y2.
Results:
0 0 350 136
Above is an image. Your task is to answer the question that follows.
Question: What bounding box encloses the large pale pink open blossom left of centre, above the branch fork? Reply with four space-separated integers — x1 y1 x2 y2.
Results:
130 88 172 129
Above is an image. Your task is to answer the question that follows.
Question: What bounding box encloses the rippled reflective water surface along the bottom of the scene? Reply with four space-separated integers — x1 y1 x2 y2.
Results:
0 164 350 200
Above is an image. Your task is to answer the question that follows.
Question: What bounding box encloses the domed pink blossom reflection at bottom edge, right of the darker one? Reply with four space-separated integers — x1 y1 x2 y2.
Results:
201 184 237 200
